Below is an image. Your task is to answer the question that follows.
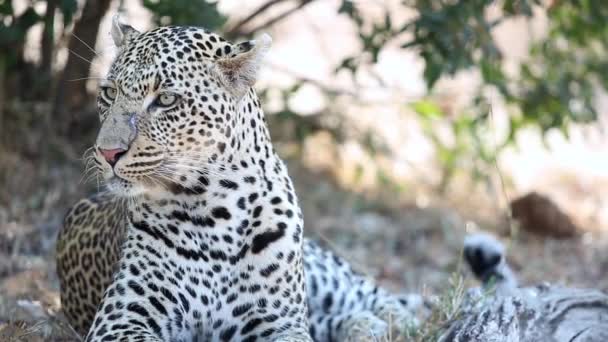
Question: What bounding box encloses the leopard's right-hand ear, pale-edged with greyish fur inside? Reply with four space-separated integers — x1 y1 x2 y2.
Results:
217 34 272 99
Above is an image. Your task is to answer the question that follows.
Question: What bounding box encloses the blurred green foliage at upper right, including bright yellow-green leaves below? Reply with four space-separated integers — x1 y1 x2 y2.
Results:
337 0 608 189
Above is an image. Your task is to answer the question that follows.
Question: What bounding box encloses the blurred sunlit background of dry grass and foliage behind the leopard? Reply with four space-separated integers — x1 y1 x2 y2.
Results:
0 0 608 340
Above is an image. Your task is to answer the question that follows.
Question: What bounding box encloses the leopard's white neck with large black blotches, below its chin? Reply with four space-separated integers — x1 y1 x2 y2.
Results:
128 147 303 265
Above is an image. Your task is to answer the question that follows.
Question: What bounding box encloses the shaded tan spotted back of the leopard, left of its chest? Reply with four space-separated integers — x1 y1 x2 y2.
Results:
56 194 126 335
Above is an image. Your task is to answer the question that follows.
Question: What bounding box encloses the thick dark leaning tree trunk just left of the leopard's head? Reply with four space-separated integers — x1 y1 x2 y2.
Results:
53 0 111 137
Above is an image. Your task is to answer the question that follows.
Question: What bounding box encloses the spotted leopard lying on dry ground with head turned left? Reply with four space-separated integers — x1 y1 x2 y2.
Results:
56 17 421 342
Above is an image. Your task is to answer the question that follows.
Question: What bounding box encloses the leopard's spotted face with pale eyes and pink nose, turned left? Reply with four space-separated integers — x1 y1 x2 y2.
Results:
95 27 268 196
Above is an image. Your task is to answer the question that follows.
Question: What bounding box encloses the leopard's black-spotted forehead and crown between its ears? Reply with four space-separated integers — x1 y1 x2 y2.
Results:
108 26 242 79
